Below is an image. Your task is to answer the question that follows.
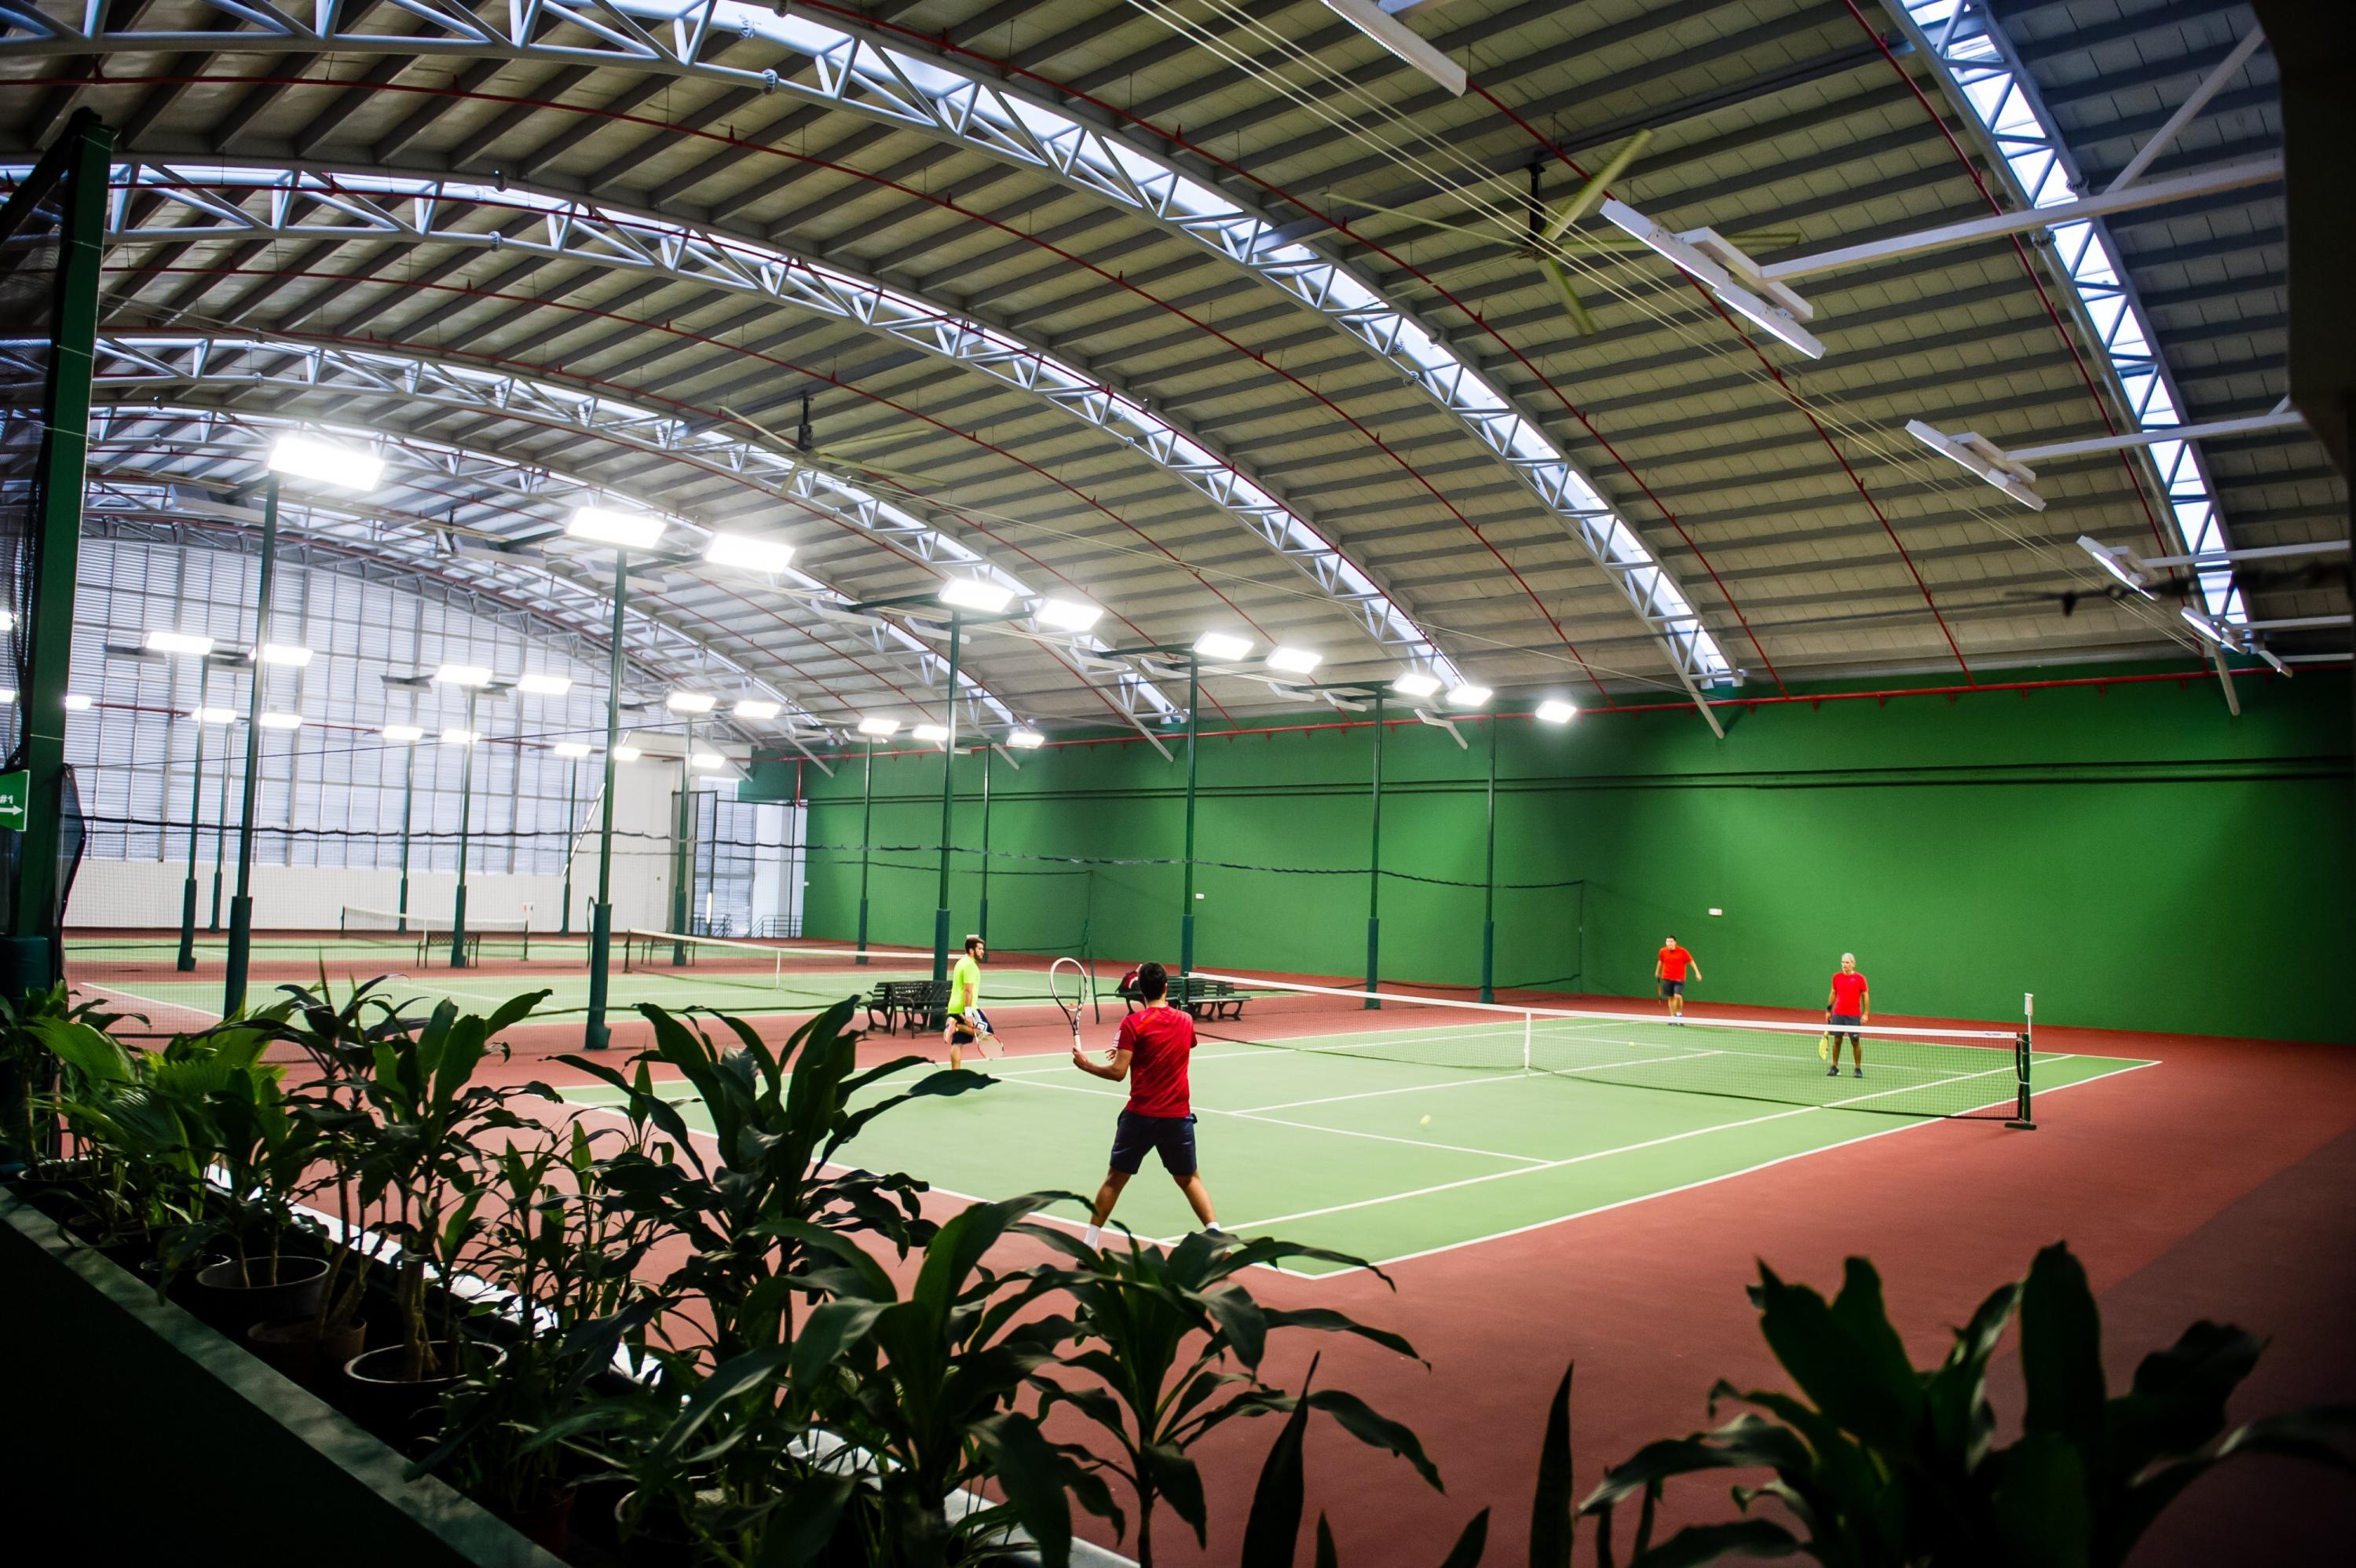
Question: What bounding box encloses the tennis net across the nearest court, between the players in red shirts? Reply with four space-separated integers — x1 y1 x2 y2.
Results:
1190 970 2031 1120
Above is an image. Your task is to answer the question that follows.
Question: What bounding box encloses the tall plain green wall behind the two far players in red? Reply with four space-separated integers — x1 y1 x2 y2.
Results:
747 671 2356 1040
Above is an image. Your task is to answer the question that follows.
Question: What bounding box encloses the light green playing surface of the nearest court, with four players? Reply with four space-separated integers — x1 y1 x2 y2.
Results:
551 1029 2149 1274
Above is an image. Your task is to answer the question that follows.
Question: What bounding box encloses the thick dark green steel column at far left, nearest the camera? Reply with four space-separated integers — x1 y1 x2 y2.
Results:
5 108 113 996
